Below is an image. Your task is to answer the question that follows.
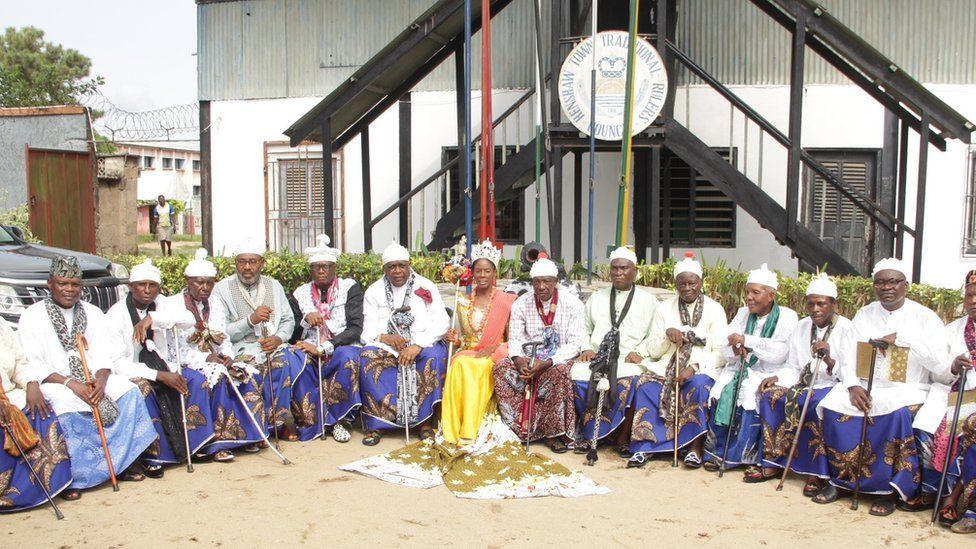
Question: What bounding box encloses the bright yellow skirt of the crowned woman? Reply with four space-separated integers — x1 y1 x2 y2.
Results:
441 355 494 444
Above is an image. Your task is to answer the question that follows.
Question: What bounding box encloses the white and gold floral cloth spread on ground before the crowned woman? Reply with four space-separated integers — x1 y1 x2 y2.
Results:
339 413 610 499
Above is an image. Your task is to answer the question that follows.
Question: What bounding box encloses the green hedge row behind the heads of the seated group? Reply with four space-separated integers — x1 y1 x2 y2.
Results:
113 252 962 322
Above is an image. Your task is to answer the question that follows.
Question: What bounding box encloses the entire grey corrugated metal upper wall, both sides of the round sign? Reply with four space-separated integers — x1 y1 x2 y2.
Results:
197 0 976 100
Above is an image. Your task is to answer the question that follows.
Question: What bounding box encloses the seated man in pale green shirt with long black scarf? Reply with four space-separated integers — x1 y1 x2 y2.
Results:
571 247 657 453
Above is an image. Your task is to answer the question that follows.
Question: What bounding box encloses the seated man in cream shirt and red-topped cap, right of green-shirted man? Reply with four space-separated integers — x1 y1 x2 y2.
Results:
627 253 728 469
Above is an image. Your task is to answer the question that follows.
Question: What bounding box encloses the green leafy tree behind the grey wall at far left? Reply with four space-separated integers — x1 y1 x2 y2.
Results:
0 27 105 107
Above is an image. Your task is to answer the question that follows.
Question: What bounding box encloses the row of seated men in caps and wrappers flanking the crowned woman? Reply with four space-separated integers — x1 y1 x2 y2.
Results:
0 236 976 533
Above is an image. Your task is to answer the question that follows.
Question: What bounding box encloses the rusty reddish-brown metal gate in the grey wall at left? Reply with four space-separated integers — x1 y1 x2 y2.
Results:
27 147 97 253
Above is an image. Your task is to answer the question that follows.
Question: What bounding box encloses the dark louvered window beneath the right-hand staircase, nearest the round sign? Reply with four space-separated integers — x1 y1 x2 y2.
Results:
660 149 736 248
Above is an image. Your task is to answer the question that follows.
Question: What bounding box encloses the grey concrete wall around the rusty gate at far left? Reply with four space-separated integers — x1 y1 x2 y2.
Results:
0 111 89 210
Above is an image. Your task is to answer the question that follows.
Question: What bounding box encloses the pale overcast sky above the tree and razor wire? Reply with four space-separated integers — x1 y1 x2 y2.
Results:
0 0 197 111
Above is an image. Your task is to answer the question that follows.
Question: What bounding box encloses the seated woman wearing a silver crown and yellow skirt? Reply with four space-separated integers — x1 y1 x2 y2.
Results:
441 240 516 445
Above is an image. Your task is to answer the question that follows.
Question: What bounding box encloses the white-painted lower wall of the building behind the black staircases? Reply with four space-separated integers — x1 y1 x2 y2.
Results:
211 85 976 287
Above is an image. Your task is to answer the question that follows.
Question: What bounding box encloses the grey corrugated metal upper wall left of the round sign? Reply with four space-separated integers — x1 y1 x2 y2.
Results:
197 0 549 101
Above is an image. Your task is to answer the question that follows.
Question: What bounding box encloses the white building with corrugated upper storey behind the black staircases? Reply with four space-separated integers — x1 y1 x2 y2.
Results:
197 0 976 287
